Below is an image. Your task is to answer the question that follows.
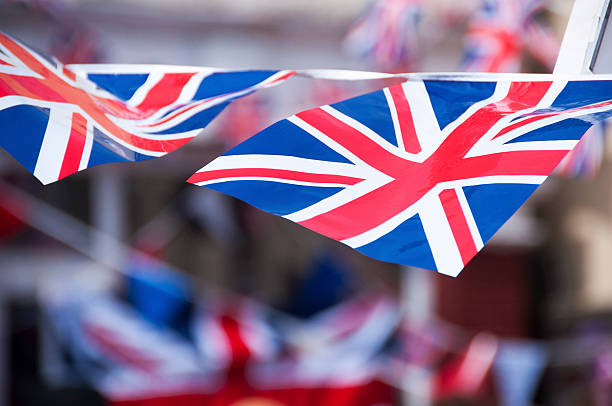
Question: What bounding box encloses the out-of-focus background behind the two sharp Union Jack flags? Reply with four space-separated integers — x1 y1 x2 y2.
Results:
0 0 612 406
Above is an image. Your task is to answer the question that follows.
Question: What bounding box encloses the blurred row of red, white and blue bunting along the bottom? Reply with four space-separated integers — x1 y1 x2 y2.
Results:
41 261 610 406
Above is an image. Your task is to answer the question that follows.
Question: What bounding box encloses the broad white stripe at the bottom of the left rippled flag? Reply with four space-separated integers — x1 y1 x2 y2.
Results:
34 106 73 185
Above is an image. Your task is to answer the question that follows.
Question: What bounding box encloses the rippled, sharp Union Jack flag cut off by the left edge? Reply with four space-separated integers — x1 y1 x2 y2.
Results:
0 32 294 184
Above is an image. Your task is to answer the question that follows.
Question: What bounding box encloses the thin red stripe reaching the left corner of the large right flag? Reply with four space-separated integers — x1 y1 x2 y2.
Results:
187 168 363 185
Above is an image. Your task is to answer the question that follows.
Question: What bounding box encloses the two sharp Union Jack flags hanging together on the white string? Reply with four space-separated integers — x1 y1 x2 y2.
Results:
0 27 612 276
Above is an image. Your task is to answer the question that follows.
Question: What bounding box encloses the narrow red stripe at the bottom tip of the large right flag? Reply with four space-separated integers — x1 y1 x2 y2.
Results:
440 189 478 265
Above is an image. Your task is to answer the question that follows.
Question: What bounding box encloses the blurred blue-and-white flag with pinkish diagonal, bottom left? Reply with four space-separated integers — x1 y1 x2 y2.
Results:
47 292 218 401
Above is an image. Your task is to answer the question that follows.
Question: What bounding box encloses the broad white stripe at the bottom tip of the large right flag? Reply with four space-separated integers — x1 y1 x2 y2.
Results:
419 193 463 276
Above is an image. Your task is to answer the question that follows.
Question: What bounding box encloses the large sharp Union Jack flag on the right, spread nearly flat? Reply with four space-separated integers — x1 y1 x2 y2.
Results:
189 76 612 276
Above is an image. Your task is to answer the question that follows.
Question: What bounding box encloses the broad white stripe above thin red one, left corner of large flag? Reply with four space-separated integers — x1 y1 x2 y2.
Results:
198 154 372 179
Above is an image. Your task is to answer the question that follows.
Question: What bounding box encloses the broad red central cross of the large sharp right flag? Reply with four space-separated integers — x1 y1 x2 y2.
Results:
298 82 567 240
